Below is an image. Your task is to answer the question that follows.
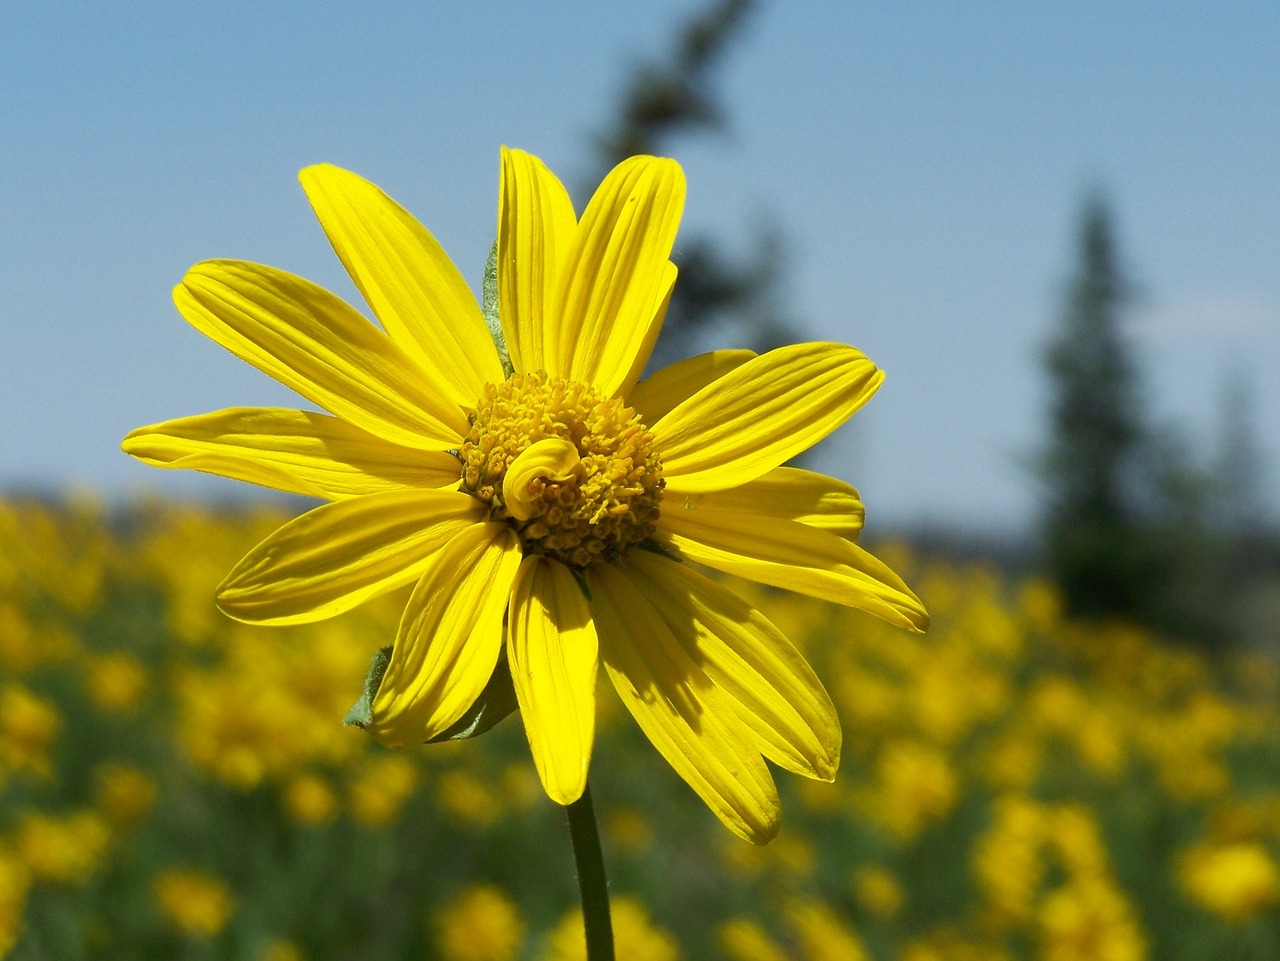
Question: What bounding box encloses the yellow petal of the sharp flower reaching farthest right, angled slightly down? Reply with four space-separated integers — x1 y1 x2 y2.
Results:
654 511 929 631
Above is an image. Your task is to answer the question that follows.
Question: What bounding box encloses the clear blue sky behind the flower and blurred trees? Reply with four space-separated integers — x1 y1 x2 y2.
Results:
0 0 1280 530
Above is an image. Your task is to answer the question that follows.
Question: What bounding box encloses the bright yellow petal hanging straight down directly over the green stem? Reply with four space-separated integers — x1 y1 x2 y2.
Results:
507 554 599 804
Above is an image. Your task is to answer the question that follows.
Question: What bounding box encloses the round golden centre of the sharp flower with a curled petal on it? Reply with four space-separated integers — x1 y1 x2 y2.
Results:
458 371 664 568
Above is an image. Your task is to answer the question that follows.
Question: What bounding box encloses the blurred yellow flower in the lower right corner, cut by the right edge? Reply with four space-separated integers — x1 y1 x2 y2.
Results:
1178 841 1280 921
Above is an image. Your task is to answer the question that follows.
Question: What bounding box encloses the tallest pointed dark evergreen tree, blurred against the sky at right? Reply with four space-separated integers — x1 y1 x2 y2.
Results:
1039 195 1158 621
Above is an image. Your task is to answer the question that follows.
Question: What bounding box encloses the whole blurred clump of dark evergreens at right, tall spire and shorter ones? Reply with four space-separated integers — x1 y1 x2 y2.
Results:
1036 193 1280 649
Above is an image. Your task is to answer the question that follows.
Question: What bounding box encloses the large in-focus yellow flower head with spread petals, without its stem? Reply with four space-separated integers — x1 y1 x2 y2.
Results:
124 150 927 841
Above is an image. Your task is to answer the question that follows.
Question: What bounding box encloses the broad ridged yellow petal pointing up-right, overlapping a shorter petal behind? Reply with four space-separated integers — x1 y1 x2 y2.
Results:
650 343 884 493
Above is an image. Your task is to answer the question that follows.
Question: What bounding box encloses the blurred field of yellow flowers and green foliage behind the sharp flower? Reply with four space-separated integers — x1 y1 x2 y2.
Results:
0 499 1280 961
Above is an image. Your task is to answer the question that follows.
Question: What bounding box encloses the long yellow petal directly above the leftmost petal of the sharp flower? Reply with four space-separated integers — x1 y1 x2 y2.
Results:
173 260 467 450
